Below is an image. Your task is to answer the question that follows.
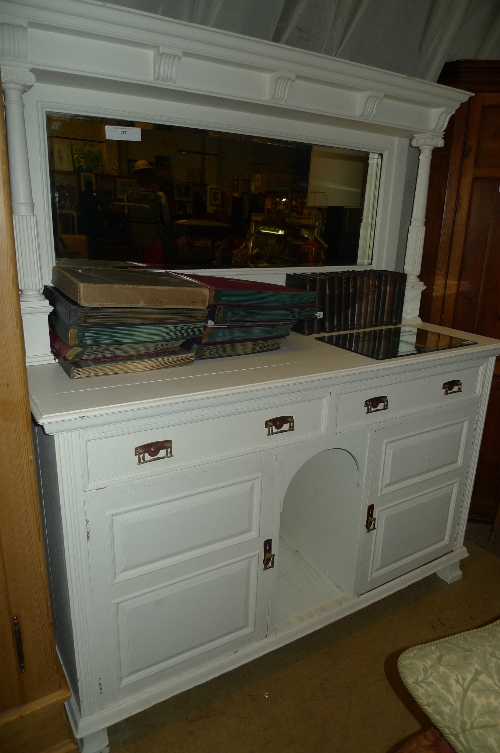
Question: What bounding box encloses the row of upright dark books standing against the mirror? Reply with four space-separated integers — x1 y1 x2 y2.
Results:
286 269 406 335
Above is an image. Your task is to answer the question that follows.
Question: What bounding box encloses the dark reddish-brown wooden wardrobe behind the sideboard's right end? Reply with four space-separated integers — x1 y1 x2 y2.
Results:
420 60 500 527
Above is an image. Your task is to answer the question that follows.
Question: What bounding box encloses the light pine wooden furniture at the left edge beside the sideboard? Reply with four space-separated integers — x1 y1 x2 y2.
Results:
0 76 78 753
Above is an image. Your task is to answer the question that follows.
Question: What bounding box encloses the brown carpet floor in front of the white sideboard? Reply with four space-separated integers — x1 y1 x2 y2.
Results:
109 545 500 753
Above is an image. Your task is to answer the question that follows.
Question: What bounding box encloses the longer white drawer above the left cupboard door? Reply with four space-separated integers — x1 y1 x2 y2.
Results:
83 390 330 489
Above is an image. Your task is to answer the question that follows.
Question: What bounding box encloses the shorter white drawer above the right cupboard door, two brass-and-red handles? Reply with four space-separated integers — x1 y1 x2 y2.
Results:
336 364 482 429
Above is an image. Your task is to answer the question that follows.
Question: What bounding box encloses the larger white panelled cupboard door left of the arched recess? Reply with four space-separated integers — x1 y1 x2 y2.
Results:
86 456 276 706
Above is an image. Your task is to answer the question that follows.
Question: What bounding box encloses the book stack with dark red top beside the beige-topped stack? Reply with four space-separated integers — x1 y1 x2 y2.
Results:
179 275 317 359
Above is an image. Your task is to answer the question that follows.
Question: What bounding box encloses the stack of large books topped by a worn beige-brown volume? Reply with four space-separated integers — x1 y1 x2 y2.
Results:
44 266 207 379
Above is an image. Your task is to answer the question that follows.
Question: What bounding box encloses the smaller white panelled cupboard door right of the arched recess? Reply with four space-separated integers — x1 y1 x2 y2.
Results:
358 406 476 593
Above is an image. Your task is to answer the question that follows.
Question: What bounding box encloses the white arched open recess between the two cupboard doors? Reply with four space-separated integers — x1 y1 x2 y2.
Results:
275 448 363 632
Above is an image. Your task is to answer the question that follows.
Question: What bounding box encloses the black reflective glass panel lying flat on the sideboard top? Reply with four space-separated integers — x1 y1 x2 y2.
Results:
316 327 477 361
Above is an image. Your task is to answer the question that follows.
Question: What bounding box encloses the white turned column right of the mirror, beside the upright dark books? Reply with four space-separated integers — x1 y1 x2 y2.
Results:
403 133 444 323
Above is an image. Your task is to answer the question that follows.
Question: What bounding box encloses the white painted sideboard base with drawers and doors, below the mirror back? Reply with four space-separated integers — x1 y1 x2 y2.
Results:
29 325 500 753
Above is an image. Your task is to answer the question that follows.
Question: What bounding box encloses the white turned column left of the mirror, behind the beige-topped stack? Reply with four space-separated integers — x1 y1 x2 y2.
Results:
2 59 53 364
